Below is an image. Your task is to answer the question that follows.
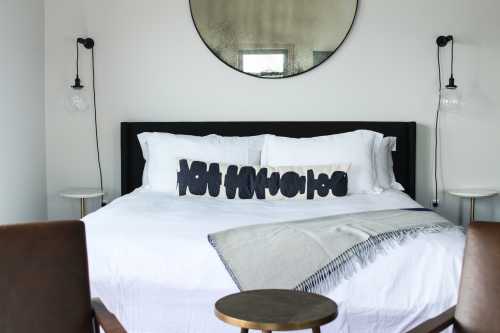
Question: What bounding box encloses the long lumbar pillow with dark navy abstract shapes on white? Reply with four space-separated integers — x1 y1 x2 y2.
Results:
177 159 350 200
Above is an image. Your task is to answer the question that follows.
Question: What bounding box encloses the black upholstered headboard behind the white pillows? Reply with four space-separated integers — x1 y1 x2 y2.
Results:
121 121 416 198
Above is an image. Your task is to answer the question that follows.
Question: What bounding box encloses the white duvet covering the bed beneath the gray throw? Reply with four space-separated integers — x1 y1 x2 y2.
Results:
84 191 465 333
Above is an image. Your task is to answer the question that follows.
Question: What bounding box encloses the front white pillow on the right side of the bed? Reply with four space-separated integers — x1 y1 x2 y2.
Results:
261 130 383 194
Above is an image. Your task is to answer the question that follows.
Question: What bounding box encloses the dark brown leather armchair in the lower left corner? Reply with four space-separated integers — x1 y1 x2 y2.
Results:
0 221 126 333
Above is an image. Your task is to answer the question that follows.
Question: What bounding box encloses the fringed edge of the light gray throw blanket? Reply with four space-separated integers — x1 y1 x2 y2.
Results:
294 223 463 293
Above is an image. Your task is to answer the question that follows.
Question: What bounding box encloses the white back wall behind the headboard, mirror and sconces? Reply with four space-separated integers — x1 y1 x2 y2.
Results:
46 0 500 220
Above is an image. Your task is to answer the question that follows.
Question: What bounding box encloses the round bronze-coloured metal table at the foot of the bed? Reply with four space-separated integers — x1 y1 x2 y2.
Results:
215 289 338 333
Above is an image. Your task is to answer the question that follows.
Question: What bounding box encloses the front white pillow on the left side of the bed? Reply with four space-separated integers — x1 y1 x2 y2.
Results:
138 133 256 194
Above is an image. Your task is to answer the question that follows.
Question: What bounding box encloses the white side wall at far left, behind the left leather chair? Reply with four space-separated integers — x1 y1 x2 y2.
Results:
0 0 47 224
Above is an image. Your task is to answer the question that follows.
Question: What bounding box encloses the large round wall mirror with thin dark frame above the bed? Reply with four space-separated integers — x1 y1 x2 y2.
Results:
190 0 358 78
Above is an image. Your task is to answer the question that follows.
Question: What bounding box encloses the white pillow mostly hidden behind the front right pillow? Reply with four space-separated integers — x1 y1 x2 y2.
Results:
375 137 404 191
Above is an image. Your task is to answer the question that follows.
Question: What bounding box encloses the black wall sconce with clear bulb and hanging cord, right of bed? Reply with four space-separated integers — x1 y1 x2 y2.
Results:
432 35 462 207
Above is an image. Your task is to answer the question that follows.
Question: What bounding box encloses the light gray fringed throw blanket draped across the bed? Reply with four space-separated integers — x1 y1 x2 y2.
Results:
208 209 458 292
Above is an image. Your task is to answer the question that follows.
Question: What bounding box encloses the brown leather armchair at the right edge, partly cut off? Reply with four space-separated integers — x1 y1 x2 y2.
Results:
409 222 500 333
